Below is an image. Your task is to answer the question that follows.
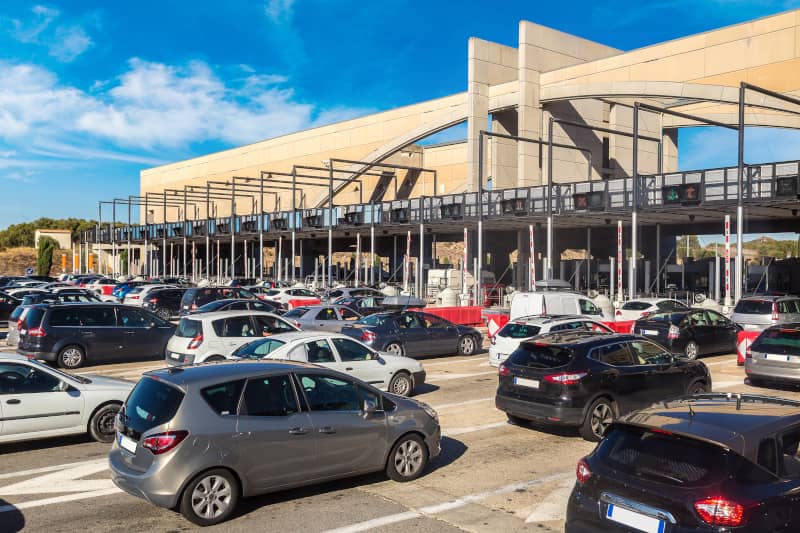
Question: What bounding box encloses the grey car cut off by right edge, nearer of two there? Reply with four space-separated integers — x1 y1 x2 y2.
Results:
744 322 800 386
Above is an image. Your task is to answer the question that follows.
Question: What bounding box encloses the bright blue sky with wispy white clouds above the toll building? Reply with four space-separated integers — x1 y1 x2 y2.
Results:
0 0 800 228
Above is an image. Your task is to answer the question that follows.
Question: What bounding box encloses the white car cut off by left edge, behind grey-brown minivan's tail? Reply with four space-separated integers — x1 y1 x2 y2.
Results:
0 353 135 442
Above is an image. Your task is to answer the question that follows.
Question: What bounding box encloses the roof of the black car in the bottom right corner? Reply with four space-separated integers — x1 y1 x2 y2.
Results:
619 393 800 457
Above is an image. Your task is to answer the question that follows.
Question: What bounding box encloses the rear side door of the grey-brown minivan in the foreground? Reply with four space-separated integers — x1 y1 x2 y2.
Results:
236 374 320 491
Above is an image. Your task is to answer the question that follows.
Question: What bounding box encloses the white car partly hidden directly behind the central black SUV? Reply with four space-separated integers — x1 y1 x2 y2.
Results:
489 316 614 366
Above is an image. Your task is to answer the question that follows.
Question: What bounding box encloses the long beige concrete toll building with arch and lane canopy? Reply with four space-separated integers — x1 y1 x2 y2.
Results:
89 10 800 299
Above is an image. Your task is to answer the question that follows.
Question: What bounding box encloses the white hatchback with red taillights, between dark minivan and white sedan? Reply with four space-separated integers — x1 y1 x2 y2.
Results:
164 311 300 366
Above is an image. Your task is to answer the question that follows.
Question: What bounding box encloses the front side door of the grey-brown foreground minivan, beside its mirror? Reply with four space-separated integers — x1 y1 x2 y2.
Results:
297 372 388 478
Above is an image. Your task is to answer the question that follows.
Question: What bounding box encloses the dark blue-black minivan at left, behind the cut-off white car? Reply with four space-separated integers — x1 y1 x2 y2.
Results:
17 303 175 369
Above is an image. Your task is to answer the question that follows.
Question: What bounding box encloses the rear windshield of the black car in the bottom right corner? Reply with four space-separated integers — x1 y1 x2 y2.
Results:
594 426 733 487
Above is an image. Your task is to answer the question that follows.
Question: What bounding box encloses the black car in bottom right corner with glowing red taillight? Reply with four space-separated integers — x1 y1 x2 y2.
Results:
565 394 800 533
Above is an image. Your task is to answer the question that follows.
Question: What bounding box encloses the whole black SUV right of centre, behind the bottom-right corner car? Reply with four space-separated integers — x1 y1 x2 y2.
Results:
495 332 711 441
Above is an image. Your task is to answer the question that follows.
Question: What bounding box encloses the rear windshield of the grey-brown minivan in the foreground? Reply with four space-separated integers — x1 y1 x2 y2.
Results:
123 377 183 432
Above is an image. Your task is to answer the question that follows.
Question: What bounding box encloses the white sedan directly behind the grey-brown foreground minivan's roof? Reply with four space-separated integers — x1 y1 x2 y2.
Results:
233 332 425 396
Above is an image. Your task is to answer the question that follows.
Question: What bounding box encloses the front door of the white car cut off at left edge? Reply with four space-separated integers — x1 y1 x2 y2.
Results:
0 362 84 437
